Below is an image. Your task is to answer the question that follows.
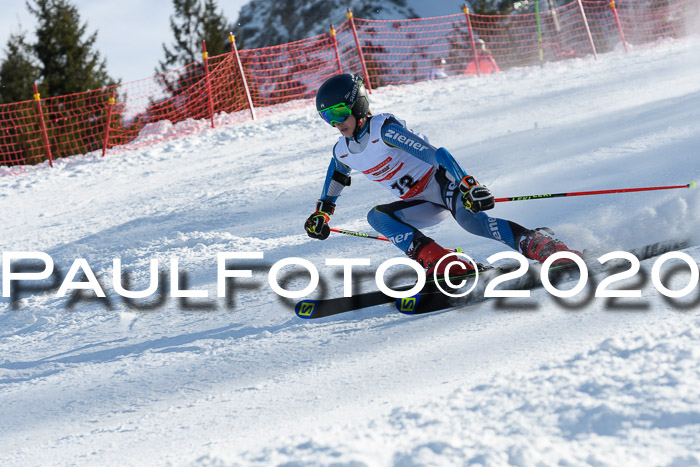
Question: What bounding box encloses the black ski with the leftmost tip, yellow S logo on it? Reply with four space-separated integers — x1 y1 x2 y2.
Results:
294 265 494 319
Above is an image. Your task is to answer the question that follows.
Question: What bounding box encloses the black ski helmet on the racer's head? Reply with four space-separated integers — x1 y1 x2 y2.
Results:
316 73 369 120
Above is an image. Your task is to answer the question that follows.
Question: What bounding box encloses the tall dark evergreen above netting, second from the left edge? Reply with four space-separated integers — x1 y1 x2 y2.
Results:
27 0 115 97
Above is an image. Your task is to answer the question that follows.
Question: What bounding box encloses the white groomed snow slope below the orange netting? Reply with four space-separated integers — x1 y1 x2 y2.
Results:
0 38 700 466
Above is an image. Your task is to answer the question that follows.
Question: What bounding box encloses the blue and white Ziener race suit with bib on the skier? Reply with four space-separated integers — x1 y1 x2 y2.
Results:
320 114 527 256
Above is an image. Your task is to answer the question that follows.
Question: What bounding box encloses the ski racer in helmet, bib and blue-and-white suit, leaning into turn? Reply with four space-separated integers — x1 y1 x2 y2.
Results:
304 74 580 274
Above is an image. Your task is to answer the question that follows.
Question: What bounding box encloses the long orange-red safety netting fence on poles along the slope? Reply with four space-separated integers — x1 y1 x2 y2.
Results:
0 0 699 172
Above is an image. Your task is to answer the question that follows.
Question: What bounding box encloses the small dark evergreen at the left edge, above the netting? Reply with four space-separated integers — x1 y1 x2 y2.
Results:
0 31 40 104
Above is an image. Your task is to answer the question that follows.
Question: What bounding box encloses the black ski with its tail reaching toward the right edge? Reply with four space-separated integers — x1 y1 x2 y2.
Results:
396 240 689 315
